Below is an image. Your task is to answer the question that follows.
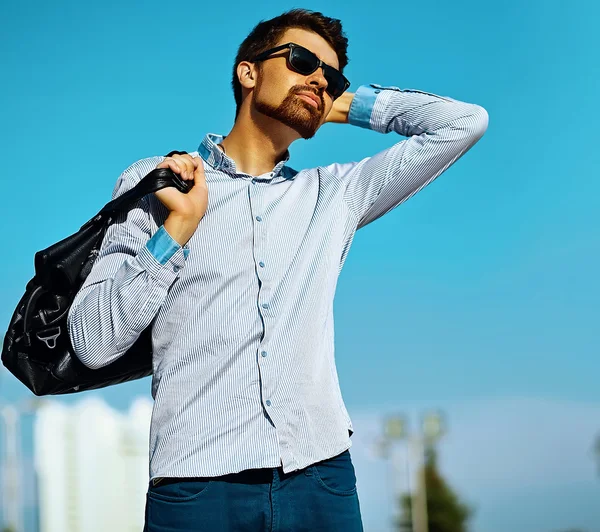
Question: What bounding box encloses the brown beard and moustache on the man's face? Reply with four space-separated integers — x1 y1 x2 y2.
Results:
254 85 325 139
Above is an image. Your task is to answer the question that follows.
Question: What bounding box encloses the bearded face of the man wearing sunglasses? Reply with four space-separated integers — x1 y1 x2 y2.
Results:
252 28 339 139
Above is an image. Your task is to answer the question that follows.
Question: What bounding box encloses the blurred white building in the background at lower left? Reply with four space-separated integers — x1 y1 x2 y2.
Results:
34 398 152 532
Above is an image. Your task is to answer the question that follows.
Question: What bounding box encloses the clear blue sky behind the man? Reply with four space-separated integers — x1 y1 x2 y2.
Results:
0 0 600 532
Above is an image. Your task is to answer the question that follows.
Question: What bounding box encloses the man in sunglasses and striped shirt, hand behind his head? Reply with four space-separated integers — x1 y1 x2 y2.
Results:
69 10 488 532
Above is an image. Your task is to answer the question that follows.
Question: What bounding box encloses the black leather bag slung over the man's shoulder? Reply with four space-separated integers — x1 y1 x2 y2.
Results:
2 152 192 396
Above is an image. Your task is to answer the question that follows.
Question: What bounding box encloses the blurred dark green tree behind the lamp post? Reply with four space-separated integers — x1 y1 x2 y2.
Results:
396 447 473 532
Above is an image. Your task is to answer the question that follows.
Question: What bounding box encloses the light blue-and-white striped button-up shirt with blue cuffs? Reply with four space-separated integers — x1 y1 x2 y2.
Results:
68 85 488 479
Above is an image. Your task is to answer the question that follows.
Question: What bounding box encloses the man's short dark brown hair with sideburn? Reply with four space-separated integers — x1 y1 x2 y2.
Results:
231 9 348 117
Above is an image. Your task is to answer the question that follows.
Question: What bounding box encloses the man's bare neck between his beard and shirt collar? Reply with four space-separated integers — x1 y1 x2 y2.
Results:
221 105 299 176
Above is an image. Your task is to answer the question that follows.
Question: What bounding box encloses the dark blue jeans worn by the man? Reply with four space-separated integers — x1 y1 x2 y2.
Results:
144 451 363 532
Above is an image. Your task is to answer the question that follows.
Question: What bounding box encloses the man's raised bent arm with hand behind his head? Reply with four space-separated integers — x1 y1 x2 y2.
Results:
327 85 488 228
